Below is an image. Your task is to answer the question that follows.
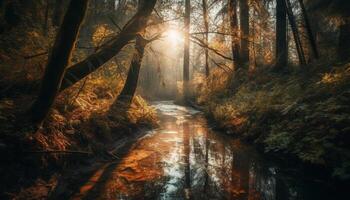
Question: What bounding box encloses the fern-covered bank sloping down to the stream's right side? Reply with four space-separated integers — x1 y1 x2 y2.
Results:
197 61 350 180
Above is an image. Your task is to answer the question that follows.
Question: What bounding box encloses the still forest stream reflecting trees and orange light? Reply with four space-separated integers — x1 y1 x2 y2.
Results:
68 101 340 200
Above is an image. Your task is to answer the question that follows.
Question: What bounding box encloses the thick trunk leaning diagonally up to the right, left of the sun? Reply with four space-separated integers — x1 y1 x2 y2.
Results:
61 0 156 91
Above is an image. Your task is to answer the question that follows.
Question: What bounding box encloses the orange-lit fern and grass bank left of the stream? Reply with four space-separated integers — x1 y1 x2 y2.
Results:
0 79 157 199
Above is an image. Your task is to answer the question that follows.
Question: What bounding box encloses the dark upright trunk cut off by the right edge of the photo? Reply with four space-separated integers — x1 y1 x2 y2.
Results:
338 17 350 62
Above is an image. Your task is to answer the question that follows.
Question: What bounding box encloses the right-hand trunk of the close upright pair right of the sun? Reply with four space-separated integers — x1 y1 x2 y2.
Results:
239 0 249 66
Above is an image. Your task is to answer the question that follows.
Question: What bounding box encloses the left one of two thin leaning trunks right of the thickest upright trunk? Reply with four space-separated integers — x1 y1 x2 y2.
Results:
285 0 306 65
